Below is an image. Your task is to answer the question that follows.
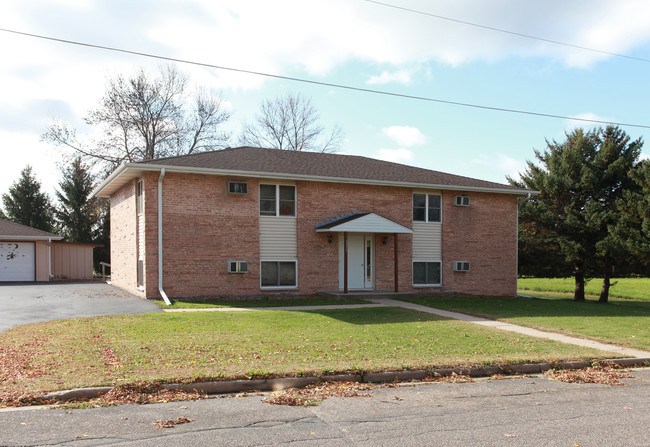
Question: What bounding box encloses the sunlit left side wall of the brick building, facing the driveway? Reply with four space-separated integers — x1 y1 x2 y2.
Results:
111 180 142 295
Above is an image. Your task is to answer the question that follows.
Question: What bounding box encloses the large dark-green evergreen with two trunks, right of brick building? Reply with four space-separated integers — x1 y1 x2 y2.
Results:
509 126 643 302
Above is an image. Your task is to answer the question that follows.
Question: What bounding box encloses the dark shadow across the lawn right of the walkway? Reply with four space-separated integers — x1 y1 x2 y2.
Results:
404 296 650 318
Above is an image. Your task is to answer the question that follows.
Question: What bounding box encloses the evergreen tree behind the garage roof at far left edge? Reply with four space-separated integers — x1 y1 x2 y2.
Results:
2 165 53 231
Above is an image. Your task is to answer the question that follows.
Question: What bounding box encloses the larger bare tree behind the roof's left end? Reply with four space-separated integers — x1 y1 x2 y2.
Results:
42 66 230 168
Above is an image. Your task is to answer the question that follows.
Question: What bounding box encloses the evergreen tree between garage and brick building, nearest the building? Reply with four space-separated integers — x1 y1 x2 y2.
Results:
54 157 101 242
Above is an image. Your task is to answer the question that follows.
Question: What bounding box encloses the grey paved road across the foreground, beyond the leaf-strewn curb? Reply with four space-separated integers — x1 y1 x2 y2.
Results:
0 369 650 447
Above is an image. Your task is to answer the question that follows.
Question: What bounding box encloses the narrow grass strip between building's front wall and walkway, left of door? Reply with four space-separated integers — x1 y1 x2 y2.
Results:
151 296 371 309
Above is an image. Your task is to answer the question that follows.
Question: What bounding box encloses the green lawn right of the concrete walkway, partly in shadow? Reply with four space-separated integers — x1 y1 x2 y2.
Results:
408 292 650 350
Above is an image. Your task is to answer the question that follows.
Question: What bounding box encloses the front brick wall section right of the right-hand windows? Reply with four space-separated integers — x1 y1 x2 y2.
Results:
442 191 517 296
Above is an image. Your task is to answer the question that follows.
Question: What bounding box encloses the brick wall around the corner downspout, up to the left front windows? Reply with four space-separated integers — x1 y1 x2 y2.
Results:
144 173 260 297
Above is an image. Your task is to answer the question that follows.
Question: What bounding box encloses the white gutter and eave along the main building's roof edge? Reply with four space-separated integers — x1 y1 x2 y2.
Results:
92 163 539 197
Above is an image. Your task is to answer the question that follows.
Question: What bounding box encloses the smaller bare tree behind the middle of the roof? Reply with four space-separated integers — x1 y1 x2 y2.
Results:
239 93 343 152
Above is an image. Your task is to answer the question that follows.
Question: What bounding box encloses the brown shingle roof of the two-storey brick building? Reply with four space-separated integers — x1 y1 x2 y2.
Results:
137 147 521 191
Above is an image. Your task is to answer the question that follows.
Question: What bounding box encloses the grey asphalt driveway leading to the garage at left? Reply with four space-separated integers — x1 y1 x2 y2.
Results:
0 282 162 332
